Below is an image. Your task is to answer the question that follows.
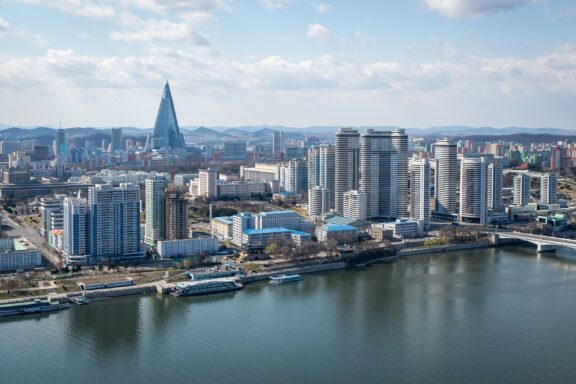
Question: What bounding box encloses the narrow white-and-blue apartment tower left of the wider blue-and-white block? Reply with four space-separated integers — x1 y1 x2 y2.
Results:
62 197 90 265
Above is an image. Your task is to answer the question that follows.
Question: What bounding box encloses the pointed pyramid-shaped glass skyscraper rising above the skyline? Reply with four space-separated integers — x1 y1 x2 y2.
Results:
146 82 186 150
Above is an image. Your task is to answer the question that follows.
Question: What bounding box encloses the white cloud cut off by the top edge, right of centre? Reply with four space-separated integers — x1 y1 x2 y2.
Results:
425 0 534 18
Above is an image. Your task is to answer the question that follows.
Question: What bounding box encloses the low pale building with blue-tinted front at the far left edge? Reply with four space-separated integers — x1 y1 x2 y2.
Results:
0 237 42 271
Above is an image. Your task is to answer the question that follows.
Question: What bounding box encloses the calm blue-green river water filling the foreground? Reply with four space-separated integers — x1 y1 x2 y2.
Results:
0 247 576 384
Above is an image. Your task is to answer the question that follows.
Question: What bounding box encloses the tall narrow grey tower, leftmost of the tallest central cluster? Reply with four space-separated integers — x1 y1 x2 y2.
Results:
334 128 360 214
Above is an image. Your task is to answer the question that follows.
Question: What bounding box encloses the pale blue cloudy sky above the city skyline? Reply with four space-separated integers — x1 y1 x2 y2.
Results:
0 0 576 130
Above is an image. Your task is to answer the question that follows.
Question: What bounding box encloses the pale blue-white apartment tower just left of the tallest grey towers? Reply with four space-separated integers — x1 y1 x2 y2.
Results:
308 145 336 208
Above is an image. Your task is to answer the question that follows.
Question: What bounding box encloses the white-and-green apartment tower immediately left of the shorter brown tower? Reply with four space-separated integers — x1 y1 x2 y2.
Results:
144 176 168 246
